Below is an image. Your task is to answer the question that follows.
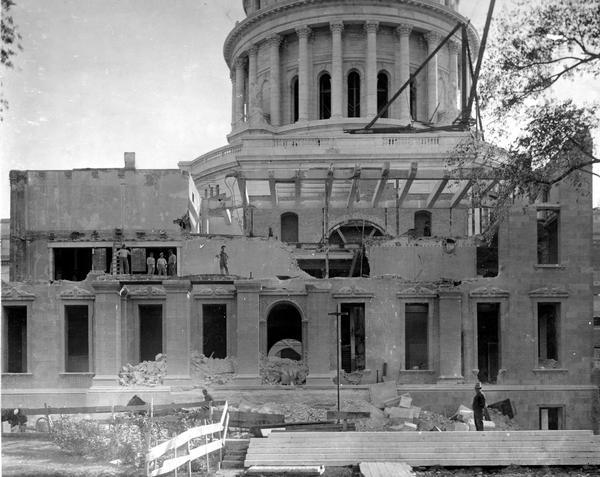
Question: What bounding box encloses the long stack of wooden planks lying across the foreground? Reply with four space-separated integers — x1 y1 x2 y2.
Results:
244 431 600 467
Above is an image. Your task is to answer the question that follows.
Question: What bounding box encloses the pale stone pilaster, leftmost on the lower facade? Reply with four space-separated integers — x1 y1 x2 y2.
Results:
92 280 122 388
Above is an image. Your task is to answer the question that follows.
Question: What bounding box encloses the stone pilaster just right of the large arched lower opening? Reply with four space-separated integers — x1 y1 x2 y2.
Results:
306 285 335 384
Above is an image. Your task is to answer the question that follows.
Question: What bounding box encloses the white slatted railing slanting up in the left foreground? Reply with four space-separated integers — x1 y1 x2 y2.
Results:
146 402 229 477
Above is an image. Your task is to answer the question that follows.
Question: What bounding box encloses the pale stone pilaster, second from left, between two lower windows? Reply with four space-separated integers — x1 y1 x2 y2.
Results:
163 280 191 385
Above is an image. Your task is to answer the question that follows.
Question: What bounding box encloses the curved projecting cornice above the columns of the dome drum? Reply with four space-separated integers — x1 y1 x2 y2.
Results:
223 0 477 66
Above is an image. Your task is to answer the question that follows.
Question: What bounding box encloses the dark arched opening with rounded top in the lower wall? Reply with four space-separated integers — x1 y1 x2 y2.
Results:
267 303 302 360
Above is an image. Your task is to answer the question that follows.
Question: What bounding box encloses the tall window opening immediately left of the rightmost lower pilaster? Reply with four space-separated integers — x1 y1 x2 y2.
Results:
404 303 429 370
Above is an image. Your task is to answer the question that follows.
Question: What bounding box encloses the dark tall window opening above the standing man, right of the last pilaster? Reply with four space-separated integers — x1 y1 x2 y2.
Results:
477 303 500 383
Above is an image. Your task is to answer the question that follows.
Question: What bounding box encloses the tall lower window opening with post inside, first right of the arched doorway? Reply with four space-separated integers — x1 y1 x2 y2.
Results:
340 303 366 373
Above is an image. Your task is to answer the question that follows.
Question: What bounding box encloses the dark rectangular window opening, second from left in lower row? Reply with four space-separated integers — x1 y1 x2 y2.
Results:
65 305 90 373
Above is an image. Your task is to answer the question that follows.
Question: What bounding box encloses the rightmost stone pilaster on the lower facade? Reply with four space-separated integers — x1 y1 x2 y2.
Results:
438 290 463 382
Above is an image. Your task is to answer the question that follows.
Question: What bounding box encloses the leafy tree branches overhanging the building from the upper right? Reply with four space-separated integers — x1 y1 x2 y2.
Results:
450 0 600 234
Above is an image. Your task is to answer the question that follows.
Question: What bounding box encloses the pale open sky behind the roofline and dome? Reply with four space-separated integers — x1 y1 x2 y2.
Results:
0 0 600 217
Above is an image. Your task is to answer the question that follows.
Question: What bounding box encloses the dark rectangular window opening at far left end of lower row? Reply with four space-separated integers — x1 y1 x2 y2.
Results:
2 306 27 373
